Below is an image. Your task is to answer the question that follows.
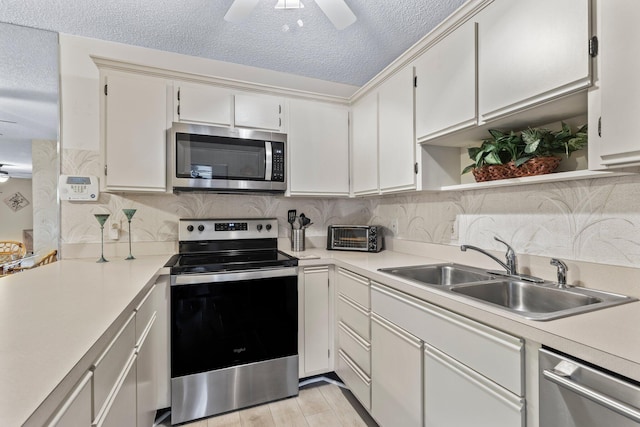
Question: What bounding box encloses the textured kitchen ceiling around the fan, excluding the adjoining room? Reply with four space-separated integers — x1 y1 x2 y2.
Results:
0 0 463 86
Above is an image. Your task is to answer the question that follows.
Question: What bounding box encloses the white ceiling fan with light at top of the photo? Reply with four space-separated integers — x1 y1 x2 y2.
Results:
224 0 357 30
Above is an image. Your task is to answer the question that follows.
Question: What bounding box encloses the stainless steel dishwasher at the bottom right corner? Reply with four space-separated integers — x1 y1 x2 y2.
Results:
539 348 640 427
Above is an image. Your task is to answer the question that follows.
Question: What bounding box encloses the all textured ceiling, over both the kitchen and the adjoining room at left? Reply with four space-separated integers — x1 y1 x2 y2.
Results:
0 0 464 177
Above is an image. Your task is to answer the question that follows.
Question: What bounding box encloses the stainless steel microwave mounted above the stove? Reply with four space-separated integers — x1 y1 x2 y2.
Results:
167 123 287 193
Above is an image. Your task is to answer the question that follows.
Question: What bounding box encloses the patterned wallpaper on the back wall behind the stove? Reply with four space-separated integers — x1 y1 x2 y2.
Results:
61 149 375 249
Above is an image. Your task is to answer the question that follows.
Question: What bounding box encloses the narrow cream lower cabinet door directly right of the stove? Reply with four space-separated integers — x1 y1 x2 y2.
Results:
302 266 331 376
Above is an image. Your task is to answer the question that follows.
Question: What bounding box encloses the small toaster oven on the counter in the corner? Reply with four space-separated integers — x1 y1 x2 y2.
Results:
327 225 383 252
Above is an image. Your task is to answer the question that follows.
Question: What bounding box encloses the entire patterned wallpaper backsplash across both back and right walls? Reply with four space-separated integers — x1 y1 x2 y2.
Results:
61 150 640 267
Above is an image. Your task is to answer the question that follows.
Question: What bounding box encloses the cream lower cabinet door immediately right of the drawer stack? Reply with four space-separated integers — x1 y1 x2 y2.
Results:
371 313 424 427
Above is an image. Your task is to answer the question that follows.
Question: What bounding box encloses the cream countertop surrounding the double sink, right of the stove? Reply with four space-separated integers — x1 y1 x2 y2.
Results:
281 242 640 381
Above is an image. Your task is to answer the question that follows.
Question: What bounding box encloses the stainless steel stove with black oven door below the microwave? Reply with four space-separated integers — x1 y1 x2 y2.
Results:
166 218 298 424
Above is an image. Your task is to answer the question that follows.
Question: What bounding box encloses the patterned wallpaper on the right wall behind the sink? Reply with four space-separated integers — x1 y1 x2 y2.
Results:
374 175 640 267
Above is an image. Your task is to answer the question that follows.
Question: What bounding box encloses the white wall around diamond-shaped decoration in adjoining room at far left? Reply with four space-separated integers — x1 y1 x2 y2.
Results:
0 178 33 242
